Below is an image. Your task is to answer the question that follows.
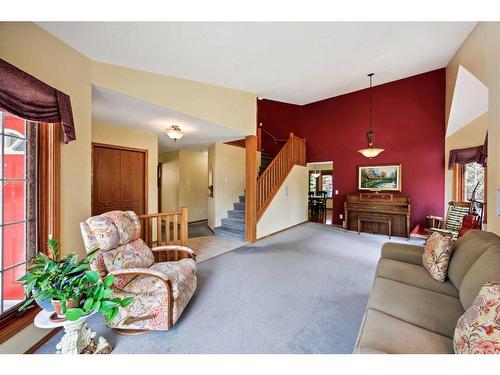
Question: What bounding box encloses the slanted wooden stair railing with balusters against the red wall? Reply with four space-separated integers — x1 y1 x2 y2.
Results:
256 133 306 221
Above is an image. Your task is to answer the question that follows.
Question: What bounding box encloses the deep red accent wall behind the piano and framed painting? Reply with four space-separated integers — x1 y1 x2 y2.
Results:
258 69 445 229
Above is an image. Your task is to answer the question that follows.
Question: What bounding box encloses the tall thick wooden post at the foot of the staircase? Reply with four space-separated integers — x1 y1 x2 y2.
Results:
245 135 257 242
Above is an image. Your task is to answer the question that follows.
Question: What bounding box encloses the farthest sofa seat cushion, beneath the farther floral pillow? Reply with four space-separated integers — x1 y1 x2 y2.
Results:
377 258 458 298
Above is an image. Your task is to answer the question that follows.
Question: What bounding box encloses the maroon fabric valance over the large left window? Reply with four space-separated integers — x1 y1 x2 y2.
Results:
0 59 76 143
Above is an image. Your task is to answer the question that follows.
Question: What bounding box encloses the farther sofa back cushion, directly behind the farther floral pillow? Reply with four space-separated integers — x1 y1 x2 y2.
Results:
448 230 500 290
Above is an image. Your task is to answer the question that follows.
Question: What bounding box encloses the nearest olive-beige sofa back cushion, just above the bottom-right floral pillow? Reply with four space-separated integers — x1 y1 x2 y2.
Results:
460 246 500 309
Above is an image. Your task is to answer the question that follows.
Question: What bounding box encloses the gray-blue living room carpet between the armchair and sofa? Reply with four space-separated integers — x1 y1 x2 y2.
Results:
38 223 420 354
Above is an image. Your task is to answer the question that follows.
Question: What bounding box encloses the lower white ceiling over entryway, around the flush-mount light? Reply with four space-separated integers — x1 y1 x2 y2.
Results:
92 86 244 152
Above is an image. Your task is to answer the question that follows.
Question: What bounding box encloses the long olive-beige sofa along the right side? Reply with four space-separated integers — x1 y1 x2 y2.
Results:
354 230 500 354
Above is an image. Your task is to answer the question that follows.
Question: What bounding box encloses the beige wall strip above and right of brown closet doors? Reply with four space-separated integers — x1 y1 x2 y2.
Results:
92 121 158 213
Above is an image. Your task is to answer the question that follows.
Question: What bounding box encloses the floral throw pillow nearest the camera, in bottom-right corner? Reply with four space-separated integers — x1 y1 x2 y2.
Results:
453 282 500 354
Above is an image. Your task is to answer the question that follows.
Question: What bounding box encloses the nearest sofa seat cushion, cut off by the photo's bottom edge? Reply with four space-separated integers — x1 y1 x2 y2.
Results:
355 309 453 354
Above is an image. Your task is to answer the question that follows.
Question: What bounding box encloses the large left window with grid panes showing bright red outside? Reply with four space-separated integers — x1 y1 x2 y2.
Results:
0 112 37 316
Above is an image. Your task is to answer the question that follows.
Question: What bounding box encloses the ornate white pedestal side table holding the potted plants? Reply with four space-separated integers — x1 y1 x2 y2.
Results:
34 310 112 354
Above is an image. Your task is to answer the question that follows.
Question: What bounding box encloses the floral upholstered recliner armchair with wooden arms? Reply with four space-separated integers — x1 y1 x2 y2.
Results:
80 211 197 333
